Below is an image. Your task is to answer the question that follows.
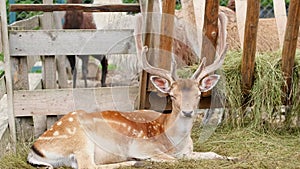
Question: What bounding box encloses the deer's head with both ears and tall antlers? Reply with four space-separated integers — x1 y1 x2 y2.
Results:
136 14 227 117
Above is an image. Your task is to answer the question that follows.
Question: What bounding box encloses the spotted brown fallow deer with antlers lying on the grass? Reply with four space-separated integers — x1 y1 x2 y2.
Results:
27 14 234 168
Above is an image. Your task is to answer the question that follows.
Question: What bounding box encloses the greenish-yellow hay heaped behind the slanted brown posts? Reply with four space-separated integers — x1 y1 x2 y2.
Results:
178 51 300 130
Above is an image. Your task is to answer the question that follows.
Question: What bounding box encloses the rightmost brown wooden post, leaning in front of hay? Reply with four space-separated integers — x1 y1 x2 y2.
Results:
282 0 300 104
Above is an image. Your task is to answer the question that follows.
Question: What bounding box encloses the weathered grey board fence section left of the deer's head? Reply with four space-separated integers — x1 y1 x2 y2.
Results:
1 0 138 149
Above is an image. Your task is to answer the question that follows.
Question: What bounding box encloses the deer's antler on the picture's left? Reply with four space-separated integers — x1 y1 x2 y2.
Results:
135 16 177 84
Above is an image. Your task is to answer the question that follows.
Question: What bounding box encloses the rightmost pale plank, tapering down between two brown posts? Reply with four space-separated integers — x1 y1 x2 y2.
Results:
273 0 287 48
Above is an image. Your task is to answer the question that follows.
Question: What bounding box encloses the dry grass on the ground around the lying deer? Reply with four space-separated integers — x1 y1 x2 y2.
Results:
0 124 300 169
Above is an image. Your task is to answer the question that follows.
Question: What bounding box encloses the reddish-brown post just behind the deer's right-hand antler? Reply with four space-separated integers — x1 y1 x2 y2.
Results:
201 0 220 65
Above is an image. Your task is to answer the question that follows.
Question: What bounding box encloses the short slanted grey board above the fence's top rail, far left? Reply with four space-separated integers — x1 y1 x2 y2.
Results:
9 15 40 30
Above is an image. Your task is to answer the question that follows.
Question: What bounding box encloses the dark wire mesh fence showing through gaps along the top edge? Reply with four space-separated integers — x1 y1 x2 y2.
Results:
6 0 290 23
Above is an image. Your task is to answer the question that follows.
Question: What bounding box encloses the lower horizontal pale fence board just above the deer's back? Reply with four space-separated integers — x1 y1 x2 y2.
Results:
14 86 138 117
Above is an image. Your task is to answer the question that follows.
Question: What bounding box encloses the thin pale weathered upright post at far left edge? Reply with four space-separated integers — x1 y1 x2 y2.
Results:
0 1 17 150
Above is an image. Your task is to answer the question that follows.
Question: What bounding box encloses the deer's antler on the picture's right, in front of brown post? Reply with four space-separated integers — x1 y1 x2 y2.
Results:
191 13 227 81
